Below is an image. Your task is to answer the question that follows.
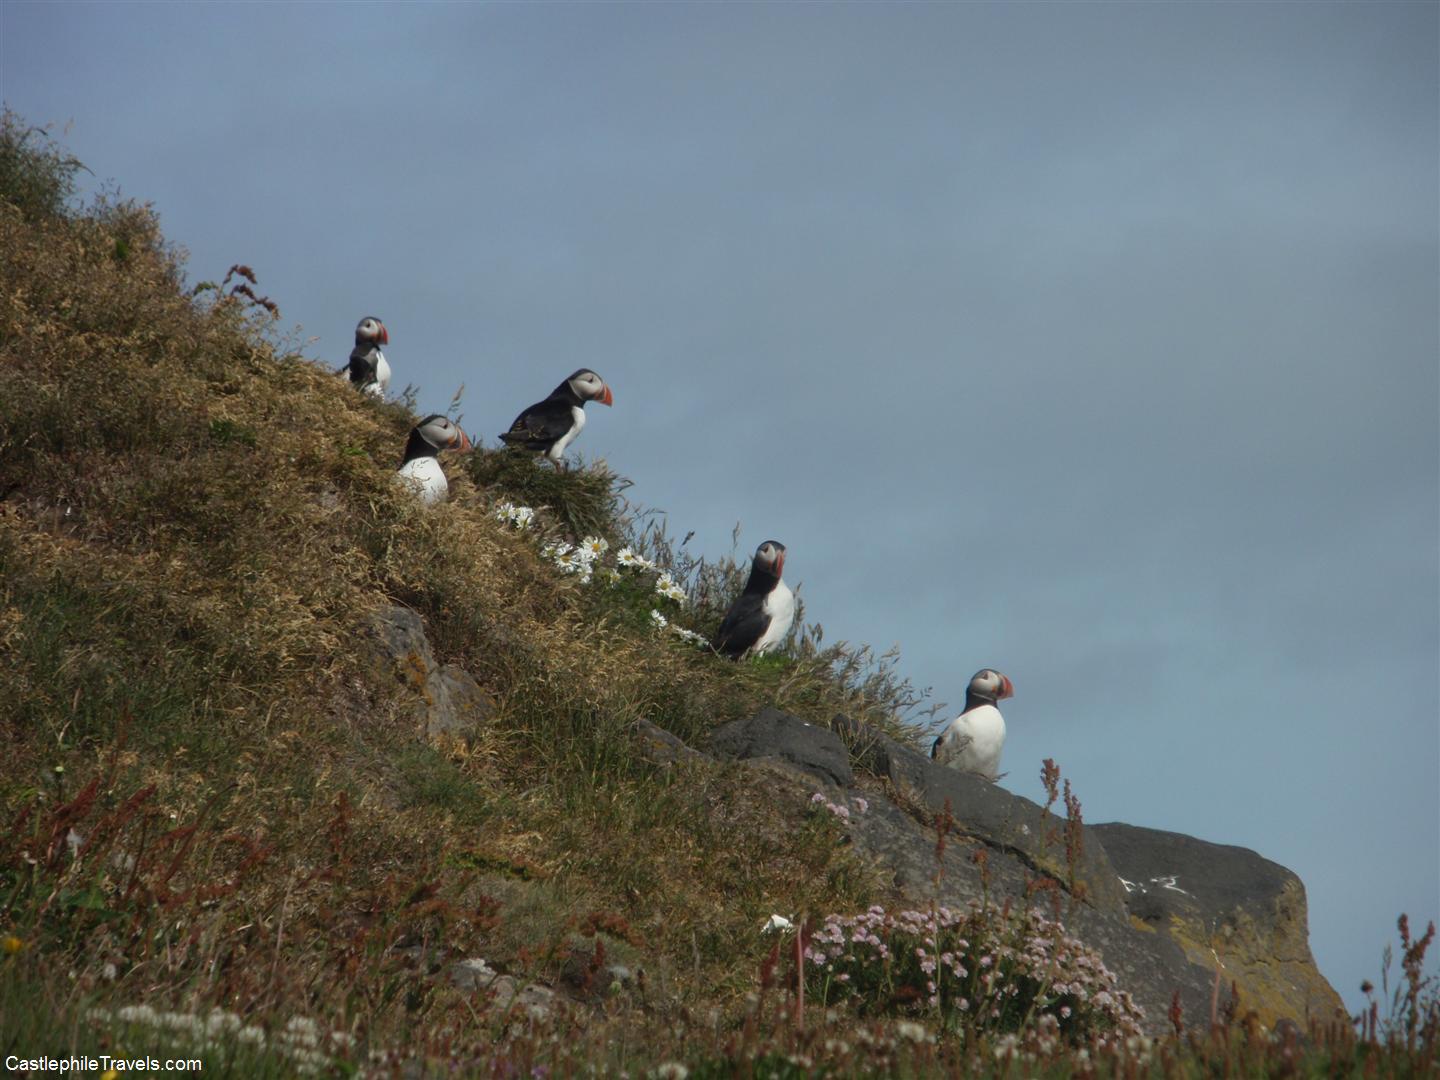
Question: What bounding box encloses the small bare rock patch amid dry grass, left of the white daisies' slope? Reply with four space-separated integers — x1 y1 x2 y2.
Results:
366 603 495 740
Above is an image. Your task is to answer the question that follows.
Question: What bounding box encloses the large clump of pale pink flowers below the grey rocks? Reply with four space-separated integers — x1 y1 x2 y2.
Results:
805 904 1143 1035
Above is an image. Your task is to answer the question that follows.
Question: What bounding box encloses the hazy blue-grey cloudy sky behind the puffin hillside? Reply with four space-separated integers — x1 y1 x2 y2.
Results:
0 0 1440 1008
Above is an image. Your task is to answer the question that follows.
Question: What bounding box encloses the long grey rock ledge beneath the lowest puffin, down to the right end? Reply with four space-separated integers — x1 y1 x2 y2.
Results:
710 708 1341 1032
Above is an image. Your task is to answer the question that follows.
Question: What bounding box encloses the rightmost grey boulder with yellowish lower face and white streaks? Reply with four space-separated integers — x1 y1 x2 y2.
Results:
1090 822 1345 1025
